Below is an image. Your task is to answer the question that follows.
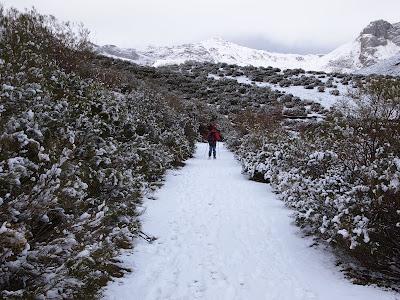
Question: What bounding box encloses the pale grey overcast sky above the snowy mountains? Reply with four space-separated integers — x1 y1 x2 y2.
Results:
0 0 400 53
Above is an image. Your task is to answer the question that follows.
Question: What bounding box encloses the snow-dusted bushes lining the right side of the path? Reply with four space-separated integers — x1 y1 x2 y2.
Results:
230 80 400 283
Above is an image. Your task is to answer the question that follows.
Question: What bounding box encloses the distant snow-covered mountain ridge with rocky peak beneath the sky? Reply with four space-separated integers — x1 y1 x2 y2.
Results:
98 20 400 72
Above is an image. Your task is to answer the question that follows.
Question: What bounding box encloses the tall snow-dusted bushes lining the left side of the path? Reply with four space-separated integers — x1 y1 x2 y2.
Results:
0 6 197 299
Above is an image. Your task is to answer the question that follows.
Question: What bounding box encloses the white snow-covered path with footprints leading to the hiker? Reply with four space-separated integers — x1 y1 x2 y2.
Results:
104 144 400 300
